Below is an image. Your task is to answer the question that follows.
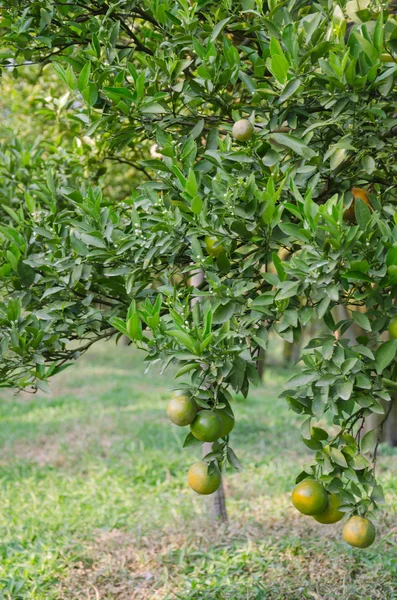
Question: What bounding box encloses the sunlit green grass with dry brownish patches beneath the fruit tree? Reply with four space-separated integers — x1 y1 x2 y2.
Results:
0 343 397 600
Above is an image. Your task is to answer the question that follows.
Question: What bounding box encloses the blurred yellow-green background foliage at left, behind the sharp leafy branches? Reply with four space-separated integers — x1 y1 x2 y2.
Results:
0 65 150 213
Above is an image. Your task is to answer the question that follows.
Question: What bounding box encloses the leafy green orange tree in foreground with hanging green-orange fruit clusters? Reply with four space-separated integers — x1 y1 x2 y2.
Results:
0 0 397 544
